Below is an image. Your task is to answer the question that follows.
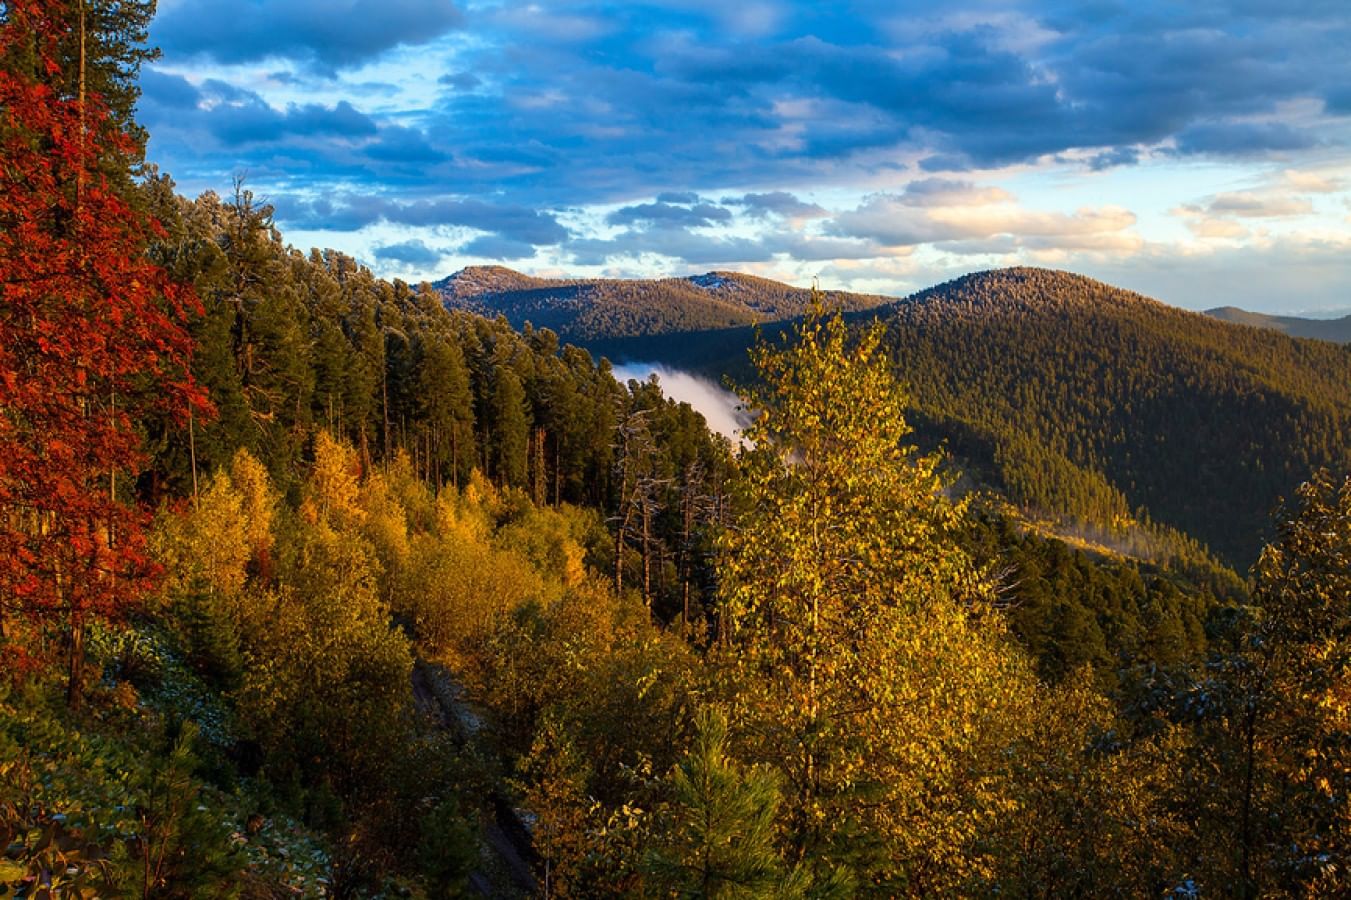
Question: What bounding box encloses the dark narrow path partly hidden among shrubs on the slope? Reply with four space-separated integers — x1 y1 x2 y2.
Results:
412 658 539 897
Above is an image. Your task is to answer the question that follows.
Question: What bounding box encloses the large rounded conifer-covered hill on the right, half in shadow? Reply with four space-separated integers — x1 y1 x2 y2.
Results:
888 269 1351 566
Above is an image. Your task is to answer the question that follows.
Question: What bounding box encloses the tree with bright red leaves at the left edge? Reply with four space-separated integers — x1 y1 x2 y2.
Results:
0 0 207 705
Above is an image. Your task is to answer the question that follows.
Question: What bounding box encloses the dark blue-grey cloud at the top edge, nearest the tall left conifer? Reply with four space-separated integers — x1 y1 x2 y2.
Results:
151 0 462 69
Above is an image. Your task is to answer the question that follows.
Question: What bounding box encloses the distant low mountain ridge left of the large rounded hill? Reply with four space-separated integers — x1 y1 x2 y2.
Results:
432 266 894 343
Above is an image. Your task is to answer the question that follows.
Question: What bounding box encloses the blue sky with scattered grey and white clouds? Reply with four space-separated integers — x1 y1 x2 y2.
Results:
139 0 1351 315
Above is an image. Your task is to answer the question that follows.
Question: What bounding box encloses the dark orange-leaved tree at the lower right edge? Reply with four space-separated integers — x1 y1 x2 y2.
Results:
1208 472 1351 897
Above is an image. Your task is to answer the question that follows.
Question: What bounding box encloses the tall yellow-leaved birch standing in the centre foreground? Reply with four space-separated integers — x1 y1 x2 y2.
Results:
719 297 1032 895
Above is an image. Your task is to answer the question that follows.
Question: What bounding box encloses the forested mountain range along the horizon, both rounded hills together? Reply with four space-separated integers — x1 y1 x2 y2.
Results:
436 268 1351 569
